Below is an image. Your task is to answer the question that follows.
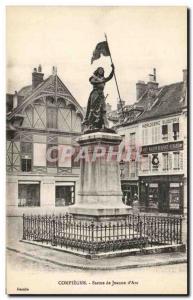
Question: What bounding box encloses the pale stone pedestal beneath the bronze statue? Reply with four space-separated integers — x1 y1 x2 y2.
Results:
70 132 131 220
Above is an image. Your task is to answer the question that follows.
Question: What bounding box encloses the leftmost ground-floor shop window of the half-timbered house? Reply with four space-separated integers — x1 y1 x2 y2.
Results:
18 183 40 207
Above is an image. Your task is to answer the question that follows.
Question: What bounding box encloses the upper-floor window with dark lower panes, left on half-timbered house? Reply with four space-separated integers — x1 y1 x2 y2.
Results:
21 142 32 172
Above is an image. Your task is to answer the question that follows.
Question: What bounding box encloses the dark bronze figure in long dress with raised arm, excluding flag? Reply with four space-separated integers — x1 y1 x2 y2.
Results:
83 64 114 132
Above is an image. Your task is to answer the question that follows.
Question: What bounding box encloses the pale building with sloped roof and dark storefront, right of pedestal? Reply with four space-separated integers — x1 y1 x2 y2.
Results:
116 69 187 214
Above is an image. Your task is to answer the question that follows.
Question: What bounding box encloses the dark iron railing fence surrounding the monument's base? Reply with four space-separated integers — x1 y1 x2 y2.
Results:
23 214 182 253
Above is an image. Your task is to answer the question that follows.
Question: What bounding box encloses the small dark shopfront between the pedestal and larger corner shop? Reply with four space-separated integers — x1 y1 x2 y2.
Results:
121 180 138 205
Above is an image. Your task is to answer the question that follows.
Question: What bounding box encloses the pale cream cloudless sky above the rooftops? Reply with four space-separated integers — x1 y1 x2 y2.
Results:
6 6 187 108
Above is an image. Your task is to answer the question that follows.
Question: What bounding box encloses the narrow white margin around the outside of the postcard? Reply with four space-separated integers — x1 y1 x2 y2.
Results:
0 0 193 299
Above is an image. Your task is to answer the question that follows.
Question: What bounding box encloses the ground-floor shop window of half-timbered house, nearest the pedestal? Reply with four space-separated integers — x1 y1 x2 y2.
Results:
55 185 75 206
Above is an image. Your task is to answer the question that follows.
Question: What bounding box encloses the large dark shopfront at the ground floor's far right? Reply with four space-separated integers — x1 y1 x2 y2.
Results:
139 175 184 214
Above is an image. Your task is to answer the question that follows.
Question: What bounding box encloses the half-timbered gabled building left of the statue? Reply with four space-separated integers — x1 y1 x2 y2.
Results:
6 66 83 215
